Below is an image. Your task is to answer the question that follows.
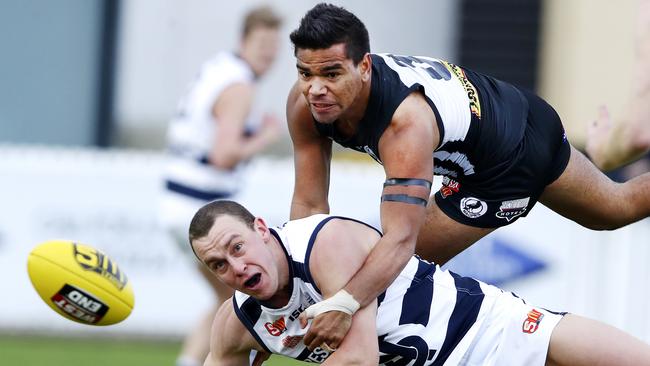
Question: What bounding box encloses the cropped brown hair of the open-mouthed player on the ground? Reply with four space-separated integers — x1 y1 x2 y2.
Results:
189 200 255 246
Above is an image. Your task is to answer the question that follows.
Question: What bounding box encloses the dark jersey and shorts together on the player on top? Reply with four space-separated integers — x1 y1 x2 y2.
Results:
316 54 569 227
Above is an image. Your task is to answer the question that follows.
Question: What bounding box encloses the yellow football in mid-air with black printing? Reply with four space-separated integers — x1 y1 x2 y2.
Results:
27 240 135 325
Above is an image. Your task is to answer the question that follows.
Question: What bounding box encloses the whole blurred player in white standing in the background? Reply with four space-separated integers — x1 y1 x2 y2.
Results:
162 6 281 366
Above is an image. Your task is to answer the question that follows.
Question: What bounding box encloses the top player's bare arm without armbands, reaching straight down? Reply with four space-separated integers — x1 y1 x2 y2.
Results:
287 86 332 220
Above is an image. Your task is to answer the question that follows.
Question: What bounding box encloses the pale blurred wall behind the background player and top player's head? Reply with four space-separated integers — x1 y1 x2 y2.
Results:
116 0 457 145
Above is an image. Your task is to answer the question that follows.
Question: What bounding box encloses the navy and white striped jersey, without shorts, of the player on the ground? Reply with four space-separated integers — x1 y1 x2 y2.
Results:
233 215 528 365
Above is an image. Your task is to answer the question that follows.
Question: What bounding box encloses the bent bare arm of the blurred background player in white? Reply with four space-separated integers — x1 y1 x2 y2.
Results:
210 83 279 169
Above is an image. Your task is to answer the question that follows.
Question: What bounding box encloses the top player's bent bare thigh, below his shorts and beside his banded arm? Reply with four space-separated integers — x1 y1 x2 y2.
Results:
415 196 494 265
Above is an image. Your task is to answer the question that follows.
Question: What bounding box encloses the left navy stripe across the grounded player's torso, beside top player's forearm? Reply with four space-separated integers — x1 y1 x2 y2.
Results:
399 261 436 327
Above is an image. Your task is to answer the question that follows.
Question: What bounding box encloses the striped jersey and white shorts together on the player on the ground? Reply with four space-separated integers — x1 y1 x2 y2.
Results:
233 215 561 366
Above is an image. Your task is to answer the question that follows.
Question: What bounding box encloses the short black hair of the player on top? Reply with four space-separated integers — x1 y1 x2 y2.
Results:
289 3 370 65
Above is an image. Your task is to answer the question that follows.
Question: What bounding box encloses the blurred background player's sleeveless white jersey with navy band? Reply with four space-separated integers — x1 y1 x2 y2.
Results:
166 52 256 202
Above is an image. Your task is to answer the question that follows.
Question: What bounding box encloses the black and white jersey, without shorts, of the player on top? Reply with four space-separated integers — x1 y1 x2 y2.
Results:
316 54 528 186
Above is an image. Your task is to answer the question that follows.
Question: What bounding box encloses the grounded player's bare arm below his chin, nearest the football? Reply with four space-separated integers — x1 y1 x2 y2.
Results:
204 299 262 366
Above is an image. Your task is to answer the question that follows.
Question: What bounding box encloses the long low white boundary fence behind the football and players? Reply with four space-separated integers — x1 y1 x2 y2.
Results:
0 145 650 342
